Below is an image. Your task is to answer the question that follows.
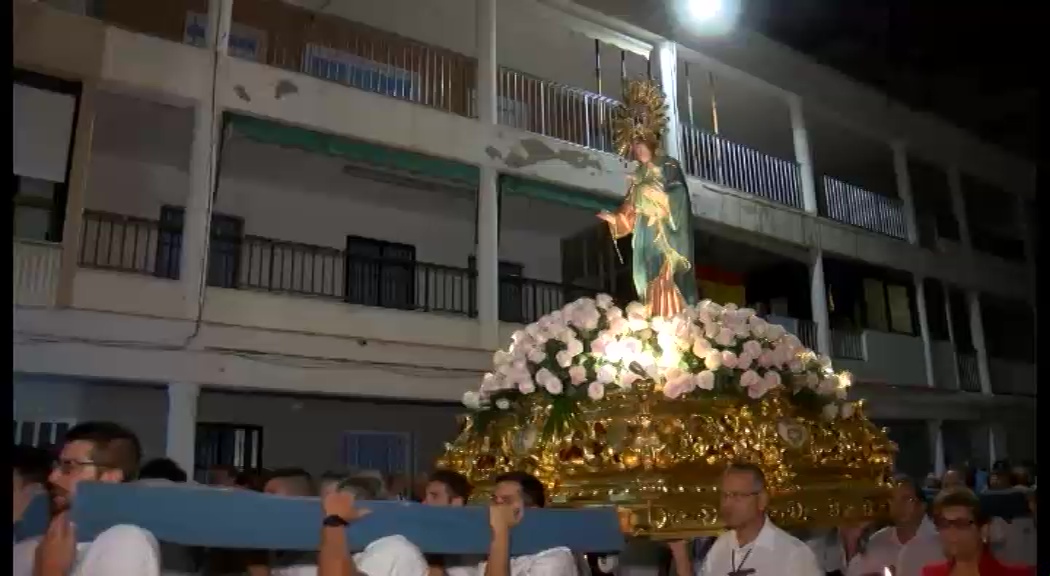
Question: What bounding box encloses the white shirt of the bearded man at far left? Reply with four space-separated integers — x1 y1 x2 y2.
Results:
12 525 161 576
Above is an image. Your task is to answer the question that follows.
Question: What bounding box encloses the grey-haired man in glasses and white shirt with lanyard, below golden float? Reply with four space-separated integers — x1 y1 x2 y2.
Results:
700 463 823 576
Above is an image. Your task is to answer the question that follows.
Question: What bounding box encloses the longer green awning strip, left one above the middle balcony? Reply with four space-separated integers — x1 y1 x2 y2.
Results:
227 112 479 188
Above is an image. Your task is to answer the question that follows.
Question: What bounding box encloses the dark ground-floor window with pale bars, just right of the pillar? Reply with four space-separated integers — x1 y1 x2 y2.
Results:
193 422 263 483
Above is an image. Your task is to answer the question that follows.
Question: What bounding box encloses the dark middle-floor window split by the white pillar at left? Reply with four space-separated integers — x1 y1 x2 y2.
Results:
156 206 245 287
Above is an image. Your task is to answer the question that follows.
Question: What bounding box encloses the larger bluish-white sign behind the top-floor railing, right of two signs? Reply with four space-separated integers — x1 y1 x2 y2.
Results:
302 44 420 97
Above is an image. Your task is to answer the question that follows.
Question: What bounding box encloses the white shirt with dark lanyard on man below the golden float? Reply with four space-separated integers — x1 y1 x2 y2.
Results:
700 518 824 576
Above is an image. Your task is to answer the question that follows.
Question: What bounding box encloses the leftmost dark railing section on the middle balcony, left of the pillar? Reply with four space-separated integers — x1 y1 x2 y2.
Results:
79 211 175 278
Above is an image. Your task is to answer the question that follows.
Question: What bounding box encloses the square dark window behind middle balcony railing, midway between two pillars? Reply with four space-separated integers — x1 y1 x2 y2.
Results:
345 236 416 310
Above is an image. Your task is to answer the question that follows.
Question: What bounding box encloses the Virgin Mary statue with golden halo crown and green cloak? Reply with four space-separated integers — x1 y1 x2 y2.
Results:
599 81 698 317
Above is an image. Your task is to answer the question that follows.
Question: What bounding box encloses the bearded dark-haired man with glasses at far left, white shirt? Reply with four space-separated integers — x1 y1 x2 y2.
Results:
13 422 161 576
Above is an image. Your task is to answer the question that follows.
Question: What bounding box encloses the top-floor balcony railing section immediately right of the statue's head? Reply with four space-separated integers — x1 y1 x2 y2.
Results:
681 124 802 208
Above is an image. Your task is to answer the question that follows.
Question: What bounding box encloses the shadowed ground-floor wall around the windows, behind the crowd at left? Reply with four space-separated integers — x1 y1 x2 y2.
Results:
13 374 462 474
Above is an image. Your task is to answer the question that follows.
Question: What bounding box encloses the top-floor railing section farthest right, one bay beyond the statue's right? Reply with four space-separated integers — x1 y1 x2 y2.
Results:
822 176 907 240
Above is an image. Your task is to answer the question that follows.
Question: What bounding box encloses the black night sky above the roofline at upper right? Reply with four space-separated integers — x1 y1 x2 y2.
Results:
741 0 1037 158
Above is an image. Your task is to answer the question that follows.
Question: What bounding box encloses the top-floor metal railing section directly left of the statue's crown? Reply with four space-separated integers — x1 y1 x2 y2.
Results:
495 67 620 152
